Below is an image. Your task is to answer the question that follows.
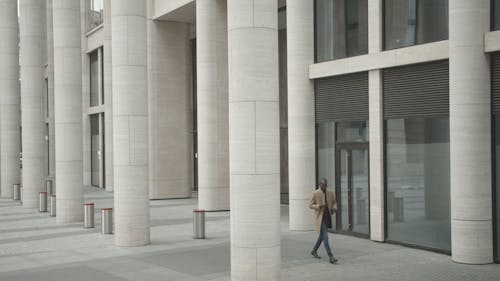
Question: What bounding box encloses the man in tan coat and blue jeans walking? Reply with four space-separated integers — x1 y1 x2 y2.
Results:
309 178 337 263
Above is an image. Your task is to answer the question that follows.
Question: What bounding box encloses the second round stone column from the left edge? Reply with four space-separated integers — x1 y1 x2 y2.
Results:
19 0 46 208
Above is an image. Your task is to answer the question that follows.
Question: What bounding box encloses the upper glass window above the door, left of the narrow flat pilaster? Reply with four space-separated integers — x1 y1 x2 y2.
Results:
315 0 368 62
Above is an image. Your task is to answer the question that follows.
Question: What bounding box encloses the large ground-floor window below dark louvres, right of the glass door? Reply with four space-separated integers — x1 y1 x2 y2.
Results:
386 116 451 251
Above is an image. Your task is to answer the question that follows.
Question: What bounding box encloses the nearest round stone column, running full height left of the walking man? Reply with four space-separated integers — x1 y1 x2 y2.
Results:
227 0 281 281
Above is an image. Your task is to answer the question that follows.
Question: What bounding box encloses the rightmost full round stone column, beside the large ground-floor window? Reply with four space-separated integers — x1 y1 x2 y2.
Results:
449 0 493 264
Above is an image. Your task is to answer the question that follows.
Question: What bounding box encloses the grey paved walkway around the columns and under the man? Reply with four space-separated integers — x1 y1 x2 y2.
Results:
0 188 500 281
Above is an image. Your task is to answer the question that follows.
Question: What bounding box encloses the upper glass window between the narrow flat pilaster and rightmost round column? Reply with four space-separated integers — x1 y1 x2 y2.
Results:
384 0 448 50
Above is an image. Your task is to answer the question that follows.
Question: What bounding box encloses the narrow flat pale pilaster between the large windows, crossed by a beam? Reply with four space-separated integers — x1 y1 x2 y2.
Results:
368 0 385 242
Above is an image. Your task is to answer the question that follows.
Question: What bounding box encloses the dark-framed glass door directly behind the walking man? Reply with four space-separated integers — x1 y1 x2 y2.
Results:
335 144 370 235
